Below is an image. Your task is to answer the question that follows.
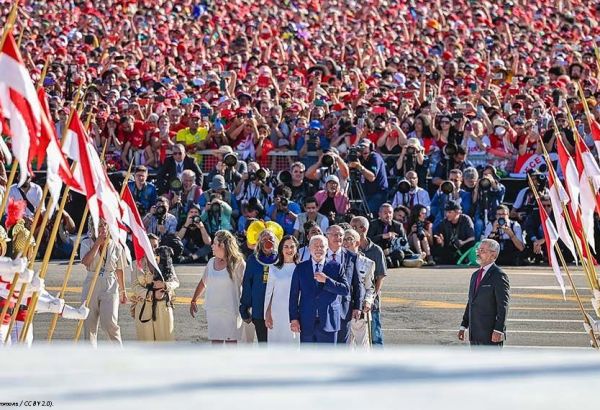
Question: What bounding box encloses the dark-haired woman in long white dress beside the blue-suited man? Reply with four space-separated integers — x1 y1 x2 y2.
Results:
265 235 300 344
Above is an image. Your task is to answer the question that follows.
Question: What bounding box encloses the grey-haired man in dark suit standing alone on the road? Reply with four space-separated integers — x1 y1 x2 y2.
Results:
458 239 510 346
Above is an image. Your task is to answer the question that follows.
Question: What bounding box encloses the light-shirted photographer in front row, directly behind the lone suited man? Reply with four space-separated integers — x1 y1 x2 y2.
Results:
484 205 525 266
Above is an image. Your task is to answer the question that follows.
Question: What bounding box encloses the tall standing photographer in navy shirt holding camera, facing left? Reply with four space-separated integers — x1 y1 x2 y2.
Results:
346 139 388 212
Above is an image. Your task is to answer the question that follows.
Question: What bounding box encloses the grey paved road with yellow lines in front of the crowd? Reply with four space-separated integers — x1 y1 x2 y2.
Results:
34 262 592 347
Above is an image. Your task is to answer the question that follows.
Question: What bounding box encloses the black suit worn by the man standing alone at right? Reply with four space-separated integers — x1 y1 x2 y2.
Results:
461 264 510 345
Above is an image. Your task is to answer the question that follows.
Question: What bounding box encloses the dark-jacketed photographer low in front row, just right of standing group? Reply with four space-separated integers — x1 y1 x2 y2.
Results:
367 203 423 268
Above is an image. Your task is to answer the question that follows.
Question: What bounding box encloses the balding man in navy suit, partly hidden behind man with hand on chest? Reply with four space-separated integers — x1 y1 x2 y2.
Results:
325 225 365 343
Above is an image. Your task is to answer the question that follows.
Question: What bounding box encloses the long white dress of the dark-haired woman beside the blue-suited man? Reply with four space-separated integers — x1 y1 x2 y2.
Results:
265 263 300 343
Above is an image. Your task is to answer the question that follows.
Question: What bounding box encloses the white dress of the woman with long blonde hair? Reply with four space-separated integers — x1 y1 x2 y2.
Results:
202 258 246 340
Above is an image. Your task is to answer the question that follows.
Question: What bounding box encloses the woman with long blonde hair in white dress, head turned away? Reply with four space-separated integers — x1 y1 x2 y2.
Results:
190 231 246 344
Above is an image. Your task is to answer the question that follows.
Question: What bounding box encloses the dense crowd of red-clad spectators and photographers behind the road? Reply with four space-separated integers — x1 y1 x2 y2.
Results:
0 0 600 342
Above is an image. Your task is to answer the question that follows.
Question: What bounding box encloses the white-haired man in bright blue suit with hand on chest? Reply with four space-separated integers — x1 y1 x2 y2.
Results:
290 235 350 343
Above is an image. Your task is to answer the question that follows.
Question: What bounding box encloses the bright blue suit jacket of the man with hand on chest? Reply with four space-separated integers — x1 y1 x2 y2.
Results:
290 258 350 336
